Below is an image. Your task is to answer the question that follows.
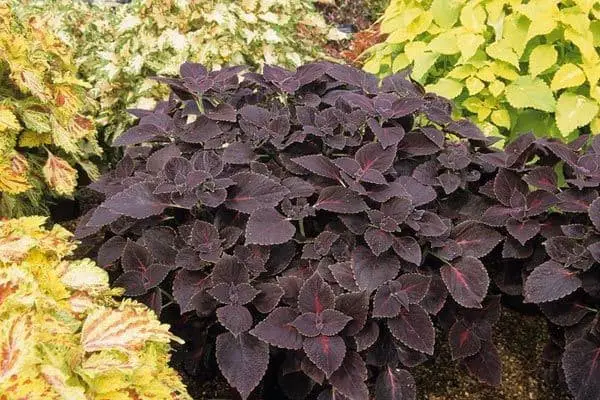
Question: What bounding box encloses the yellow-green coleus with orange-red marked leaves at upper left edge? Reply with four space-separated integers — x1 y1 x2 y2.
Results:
0 2 101 217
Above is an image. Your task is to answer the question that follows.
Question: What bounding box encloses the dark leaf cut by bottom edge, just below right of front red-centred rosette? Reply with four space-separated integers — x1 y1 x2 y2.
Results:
329 351 369 400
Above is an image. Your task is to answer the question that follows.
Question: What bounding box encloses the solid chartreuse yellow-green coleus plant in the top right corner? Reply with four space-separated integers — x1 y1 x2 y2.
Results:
364 0 600 145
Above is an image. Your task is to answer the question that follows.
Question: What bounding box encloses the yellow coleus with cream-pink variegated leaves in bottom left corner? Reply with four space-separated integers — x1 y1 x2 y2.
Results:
0 216 191 400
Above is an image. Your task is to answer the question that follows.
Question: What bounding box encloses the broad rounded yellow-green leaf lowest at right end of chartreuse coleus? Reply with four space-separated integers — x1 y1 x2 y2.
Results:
556 92 598 135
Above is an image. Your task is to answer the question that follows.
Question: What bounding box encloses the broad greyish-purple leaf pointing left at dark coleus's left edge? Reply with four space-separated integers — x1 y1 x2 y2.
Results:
102 182 169 219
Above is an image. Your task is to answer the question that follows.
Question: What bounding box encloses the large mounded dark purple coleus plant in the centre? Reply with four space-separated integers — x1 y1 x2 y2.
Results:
76 62 516 400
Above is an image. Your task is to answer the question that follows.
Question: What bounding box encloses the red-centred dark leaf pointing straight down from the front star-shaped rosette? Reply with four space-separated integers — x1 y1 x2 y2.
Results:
302 335 346 378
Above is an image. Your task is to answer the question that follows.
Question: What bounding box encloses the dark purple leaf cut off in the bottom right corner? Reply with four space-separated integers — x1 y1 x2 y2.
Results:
562 338 600 400
